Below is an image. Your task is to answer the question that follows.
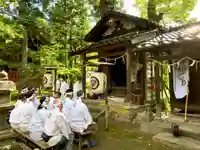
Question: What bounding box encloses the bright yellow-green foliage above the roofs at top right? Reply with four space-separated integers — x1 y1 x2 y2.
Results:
136 0 197 23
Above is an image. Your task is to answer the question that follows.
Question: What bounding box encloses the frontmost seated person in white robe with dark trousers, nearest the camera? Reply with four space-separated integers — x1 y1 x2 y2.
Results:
42 103 74 150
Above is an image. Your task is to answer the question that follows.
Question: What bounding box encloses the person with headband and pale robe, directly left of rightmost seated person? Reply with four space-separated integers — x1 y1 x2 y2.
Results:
62 89 74 122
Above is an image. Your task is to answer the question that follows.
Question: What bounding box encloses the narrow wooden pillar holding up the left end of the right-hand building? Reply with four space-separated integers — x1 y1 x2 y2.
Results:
155 54 161 118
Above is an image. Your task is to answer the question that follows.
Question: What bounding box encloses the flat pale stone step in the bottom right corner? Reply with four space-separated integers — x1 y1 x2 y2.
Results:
153 132 200 150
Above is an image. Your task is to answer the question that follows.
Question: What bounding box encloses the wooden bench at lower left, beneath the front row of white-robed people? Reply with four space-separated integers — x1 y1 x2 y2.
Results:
12 128 53 150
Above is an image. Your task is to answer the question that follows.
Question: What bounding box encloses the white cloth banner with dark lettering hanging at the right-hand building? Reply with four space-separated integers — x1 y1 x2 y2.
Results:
173 61 189 99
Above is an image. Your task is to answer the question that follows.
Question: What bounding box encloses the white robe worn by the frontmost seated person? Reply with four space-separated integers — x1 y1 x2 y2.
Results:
44 108 72 146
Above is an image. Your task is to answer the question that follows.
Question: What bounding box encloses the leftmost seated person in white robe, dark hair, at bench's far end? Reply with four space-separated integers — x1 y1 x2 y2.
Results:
9 88 28 128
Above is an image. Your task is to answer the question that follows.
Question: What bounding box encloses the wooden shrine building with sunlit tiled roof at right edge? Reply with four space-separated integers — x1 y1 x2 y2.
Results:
137 22 200 113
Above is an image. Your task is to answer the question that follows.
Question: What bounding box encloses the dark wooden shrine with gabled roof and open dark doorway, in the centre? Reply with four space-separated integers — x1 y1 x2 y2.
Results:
71 12 161 105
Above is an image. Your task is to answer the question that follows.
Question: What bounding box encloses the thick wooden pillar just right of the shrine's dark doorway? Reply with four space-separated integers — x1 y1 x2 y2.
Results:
125 48 132 103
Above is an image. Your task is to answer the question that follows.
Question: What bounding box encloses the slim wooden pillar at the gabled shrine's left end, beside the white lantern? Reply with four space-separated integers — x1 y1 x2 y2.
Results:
81 54 86 97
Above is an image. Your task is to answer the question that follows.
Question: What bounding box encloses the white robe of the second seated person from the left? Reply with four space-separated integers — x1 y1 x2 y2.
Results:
19 101 36 132
